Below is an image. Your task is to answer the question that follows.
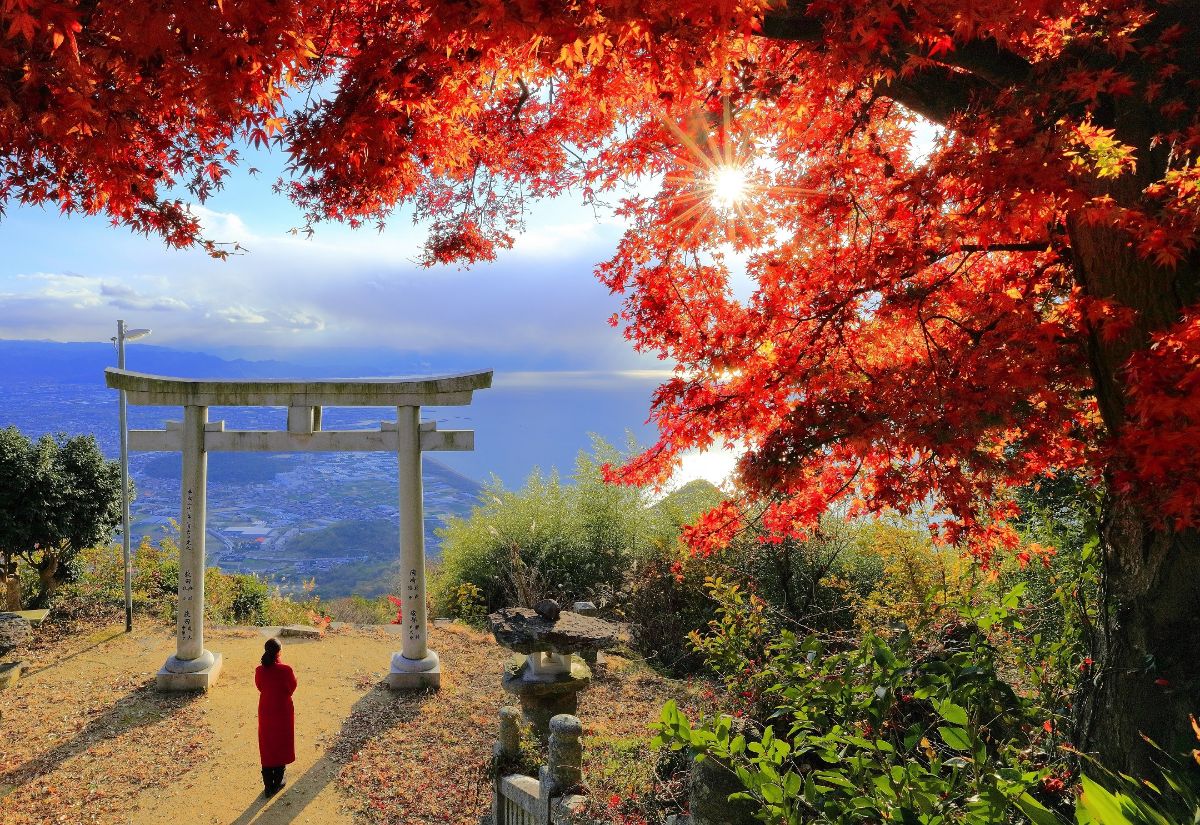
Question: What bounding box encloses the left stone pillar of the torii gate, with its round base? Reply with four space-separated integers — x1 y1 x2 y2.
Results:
157 407 221 691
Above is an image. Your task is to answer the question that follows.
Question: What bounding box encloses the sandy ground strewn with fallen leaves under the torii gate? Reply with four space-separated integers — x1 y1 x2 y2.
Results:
0 625 504 825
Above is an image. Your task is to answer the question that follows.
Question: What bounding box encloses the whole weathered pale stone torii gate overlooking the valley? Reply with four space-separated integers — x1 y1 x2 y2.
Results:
104 368 492 691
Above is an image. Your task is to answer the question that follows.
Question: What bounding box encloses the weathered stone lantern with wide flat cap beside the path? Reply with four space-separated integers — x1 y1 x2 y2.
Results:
488 600 617 740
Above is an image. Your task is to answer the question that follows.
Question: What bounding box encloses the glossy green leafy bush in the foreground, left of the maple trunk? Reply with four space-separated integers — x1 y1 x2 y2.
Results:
654 582 1050 824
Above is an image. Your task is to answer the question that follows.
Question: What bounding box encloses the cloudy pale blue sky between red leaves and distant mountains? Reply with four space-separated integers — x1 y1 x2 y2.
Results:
0 193 655 369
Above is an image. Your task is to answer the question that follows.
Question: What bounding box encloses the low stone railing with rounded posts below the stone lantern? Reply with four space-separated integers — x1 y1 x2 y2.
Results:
492 707 584 825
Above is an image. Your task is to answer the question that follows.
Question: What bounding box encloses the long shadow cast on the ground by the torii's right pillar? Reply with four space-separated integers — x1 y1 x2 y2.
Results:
230 685 433 825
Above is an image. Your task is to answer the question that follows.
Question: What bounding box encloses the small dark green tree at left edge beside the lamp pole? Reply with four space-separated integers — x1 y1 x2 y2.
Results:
0 427 121 607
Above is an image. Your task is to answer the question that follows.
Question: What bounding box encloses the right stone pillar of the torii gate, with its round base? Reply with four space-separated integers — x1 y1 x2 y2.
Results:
385 407 442 689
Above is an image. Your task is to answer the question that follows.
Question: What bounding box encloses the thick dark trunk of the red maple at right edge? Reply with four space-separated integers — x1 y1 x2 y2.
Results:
1069 205 1200 777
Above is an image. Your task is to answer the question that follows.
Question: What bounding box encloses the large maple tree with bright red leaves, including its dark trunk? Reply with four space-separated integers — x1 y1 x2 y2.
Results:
0 0 1200 769
